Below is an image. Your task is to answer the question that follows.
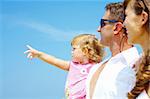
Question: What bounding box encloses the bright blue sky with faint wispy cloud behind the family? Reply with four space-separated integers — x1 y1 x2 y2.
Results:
0 0 142 99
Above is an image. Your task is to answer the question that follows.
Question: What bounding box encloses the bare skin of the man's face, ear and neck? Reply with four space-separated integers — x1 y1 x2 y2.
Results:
97 10 131 56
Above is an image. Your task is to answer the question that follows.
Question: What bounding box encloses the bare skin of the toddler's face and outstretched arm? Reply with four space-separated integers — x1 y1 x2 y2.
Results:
24 45 89 71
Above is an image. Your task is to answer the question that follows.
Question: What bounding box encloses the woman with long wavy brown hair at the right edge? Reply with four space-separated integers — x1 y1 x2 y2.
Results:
124 0 150 99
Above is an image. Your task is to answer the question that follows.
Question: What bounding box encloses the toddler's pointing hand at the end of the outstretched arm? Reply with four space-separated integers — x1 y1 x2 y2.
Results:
24 45 41 59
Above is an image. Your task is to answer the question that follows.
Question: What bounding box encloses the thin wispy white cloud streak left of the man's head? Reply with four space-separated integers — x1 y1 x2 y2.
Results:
19 21 97 41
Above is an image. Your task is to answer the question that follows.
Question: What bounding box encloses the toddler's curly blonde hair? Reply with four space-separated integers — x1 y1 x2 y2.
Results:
71 34 104 63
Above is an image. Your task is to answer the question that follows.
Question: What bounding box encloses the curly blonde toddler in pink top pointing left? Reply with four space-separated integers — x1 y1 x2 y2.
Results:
25 34 104 99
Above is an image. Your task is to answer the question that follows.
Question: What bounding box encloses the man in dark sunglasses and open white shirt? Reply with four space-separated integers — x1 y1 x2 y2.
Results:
87 3 139 99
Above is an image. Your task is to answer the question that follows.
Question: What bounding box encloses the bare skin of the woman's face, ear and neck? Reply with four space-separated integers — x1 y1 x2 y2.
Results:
124 0 148 52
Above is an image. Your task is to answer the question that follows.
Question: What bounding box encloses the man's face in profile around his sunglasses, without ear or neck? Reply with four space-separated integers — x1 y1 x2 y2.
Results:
98 10 113 46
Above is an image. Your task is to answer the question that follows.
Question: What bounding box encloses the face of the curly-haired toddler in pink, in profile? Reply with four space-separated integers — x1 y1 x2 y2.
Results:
72 45 89 64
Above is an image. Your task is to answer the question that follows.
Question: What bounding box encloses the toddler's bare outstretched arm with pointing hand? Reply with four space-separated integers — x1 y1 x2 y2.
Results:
24 45 69 71
